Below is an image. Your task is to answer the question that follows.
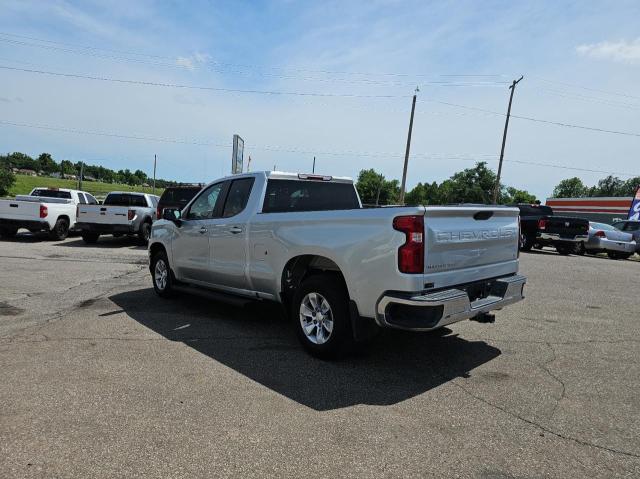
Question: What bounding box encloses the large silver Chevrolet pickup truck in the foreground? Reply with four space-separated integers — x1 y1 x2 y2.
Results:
149 172 526 357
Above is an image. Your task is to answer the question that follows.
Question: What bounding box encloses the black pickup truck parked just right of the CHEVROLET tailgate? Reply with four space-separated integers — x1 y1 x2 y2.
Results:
517 204 589 255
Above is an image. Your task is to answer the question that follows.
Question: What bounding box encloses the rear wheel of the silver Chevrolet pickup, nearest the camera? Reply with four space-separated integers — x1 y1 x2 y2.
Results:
291 274 354 359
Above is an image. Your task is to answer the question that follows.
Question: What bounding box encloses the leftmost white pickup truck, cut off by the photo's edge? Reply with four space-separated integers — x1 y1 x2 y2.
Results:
0 188 98 240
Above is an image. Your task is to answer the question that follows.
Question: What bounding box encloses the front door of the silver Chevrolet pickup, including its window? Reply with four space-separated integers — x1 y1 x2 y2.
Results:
172 181 228 283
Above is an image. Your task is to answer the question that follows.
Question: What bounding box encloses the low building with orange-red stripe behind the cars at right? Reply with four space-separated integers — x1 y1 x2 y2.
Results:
546 196 633 224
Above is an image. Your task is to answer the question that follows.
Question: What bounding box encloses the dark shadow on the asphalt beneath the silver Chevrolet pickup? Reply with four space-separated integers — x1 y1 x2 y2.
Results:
106 289 501 411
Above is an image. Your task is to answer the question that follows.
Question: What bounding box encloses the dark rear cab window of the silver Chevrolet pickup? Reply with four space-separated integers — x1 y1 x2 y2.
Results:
262 179 360 213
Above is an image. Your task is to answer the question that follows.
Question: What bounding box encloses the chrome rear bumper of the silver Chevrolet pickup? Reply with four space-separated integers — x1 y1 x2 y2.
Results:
376 275 527 331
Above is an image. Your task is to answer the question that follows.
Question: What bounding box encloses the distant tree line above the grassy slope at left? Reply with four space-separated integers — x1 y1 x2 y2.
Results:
0 152 176 194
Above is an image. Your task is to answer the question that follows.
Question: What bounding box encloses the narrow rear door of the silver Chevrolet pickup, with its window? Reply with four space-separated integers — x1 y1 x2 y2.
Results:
209 178 254 289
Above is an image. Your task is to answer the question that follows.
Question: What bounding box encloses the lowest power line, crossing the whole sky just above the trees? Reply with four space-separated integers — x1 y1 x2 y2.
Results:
0 119 640 177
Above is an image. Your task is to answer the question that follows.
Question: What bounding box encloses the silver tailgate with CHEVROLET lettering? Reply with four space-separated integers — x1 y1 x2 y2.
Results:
424 206 520 284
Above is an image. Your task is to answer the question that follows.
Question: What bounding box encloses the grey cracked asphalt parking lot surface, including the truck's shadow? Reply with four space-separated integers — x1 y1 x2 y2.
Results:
0 235 640 478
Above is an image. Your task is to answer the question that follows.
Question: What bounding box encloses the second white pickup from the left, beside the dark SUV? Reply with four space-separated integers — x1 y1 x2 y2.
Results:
77 191 158 244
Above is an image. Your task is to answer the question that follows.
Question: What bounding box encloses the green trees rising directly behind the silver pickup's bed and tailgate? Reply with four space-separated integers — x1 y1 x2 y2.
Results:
356 162 536 205
